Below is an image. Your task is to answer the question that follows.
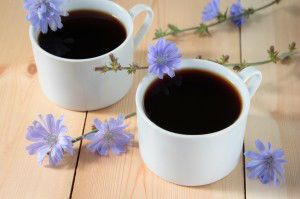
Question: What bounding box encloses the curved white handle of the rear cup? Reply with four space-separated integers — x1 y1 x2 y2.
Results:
129 4 153 48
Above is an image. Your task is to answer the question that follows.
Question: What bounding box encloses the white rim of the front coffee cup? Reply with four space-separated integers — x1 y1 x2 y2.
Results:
135 59 250 139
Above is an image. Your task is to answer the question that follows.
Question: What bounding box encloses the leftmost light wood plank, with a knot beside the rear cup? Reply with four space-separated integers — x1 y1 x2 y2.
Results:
0 1 85 199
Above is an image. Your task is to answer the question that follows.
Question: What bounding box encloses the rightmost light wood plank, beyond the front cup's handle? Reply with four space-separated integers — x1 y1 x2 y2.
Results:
242 0 300 199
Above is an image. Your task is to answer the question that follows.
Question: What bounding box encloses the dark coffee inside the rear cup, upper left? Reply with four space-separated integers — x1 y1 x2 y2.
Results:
38 10 126 59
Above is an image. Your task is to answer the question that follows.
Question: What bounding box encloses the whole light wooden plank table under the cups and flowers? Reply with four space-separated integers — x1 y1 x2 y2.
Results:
0 0 300 199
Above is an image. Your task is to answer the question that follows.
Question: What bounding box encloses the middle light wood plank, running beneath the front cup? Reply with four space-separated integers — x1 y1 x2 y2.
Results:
73 0 244 199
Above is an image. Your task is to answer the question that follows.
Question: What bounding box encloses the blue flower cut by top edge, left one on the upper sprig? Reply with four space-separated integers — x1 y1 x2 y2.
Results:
202 0 220 22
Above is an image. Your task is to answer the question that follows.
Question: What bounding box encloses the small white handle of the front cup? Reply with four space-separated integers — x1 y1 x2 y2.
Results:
238 67 262 98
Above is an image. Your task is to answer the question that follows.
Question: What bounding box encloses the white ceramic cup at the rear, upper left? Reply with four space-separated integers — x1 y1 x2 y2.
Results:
29 0 153 111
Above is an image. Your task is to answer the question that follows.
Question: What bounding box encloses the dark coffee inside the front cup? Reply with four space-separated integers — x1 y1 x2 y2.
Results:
144 69 242 135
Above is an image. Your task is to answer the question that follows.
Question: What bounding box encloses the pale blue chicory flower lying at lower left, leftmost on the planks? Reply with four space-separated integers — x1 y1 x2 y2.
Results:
26 114 74 165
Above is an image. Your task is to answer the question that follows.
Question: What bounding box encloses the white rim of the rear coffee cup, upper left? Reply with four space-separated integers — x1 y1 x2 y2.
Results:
29 1 133 63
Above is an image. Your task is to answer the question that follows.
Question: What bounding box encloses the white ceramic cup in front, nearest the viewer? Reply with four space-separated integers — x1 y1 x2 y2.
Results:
135 59 262 186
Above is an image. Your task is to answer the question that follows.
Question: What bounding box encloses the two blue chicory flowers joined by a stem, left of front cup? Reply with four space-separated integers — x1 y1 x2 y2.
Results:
26 114 133 165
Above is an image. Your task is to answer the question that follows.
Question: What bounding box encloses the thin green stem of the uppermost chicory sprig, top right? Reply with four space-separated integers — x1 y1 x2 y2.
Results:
154 0 280 39
